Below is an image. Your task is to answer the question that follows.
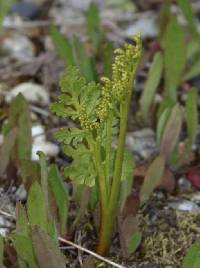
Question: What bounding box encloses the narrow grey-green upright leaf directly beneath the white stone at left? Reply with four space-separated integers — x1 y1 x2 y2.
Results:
38 151 51 219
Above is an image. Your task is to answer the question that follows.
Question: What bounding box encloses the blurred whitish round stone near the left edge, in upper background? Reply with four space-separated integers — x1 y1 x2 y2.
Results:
2 34 35 62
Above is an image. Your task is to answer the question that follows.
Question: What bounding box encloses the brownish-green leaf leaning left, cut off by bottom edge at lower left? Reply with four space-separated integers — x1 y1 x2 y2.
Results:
32 226 66 268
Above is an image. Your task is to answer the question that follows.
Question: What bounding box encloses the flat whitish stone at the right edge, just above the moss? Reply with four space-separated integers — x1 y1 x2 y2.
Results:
168 199 200 212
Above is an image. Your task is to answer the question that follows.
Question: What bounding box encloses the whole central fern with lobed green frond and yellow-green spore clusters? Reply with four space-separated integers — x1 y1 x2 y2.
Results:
52 35 142 255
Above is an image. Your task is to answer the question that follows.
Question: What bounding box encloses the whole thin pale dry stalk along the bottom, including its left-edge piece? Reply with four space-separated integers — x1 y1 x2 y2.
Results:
0 209 126 268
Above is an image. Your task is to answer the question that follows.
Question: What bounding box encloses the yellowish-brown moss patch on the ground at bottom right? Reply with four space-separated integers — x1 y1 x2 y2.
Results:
140 209 200 268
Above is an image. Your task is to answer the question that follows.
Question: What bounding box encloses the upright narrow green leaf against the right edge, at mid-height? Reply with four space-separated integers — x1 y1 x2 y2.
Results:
186 88 198 146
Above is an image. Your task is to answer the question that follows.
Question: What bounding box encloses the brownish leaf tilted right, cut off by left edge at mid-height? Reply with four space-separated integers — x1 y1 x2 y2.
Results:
0 128 17 175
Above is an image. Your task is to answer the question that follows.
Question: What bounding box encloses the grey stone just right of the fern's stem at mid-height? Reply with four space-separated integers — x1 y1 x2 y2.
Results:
126 128 158 159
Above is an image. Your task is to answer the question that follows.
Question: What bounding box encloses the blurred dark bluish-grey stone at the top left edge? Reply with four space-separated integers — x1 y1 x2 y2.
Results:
11 2 41 20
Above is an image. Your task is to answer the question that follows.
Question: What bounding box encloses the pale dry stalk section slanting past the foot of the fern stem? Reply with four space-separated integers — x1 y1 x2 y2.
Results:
58 237 126 268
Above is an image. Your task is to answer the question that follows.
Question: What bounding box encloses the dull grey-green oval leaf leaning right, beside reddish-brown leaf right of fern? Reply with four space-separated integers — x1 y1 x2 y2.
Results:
140 156 165 204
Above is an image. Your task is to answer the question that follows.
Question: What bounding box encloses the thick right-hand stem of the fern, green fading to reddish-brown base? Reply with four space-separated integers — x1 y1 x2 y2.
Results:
97 90 132 255
